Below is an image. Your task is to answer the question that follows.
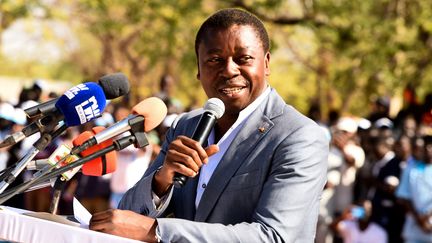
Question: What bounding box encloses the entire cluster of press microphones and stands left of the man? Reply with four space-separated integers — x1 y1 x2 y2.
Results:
0 73 167 209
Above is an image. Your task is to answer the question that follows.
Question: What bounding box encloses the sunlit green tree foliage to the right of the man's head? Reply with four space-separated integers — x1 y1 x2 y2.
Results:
230 0 432 115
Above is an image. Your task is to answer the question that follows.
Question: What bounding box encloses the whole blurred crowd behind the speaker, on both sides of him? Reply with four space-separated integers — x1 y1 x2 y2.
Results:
0 75 432 243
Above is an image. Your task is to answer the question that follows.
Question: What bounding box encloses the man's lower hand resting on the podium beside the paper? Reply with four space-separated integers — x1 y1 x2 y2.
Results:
89 209 157 242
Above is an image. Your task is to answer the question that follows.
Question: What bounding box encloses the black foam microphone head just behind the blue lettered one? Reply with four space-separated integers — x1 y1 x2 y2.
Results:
98 73 130 100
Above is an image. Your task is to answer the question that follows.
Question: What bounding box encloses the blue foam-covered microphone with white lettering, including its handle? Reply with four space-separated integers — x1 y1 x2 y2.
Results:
0 82 106 148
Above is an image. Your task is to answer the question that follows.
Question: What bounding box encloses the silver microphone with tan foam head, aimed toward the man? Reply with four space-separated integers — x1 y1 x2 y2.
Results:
71 97 167 154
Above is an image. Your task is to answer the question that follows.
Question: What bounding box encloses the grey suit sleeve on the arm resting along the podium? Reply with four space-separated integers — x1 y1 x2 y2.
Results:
157 123 328 243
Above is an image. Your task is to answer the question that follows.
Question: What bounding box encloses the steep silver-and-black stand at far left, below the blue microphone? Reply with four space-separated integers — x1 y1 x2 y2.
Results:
0 124 67 194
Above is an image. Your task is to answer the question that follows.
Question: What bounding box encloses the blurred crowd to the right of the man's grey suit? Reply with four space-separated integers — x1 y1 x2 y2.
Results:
309 84 432 243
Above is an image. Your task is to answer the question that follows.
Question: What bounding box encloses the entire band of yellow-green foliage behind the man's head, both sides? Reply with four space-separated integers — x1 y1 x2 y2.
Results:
0 0 432 115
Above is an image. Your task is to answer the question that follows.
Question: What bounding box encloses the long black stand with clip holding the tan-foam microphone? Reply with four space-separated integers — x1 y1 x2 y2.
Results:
0 116 149 205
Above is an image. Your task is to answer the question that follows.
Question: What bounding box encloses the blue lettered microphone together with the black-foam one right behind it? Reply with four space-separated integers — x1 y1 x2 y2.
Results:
0 73 129 148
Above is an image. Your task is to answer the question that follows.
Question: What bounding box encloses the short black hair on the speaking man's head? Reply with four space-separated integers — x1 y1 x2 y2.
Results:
195 8 270 57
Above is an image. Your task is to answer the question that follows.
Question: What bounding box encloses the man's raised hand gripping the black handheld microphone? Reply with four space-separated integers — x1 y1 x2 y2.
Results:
153 136 219 196
